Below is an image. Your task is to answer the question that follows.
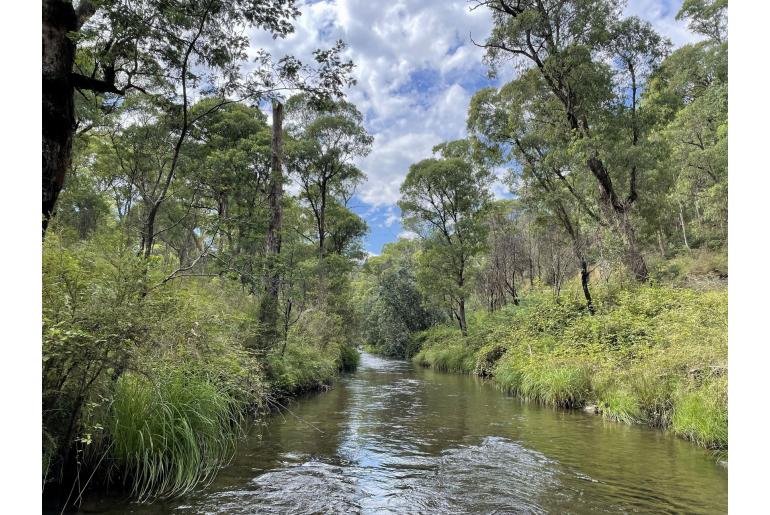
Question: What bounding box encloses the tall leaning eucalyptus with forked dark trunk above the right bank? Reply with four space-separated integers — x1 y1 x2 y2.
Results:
468 0 667 281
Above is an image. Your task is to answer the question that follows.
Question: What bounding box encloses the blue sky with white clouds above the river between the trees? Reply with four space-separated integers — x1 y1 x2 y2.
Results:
251 0 696 254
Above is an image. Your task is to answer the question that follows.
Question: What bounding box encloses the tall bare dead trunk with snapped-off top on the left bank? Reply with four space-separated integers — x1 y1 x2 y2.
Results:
259 101 283 346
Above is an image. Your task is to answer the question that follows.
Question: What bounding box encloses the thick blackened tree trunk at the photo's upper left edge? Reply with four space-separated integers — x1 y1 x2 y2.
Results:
42 0 78 236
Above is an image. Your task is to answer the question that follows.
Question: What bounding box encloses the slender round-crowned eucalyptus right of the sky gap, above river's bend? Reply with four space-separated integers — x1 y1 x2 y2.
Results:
398 142 491 335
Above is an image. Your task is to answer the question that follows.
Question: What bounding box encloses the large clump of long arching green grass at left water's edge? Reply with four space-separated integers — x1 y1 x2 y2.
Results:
109 369 243 501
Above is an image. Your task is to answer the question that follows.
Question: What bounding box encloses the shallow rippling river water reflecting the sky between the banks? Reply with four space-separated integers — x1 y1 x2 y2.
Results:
82 353 727 514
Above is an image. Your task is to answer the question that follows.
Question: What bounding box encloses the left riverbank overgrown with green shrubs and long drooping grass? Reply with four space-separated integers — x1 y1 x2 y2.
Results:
42 234 359 506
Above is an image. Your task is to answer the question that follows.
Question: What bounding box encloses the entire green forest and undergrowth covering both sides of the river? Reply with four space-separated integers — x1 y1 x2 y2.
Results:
42 0 728 504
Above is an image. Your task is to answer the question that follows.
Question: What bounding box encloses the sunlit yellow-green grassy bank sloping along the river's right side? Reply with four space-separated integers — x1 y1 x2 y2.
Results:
413 285 727 450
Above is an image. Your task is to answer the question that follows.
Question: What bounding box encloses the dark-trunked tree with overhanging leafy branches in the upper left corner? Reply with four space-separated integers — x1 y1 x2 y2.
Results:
42 0 352 234
